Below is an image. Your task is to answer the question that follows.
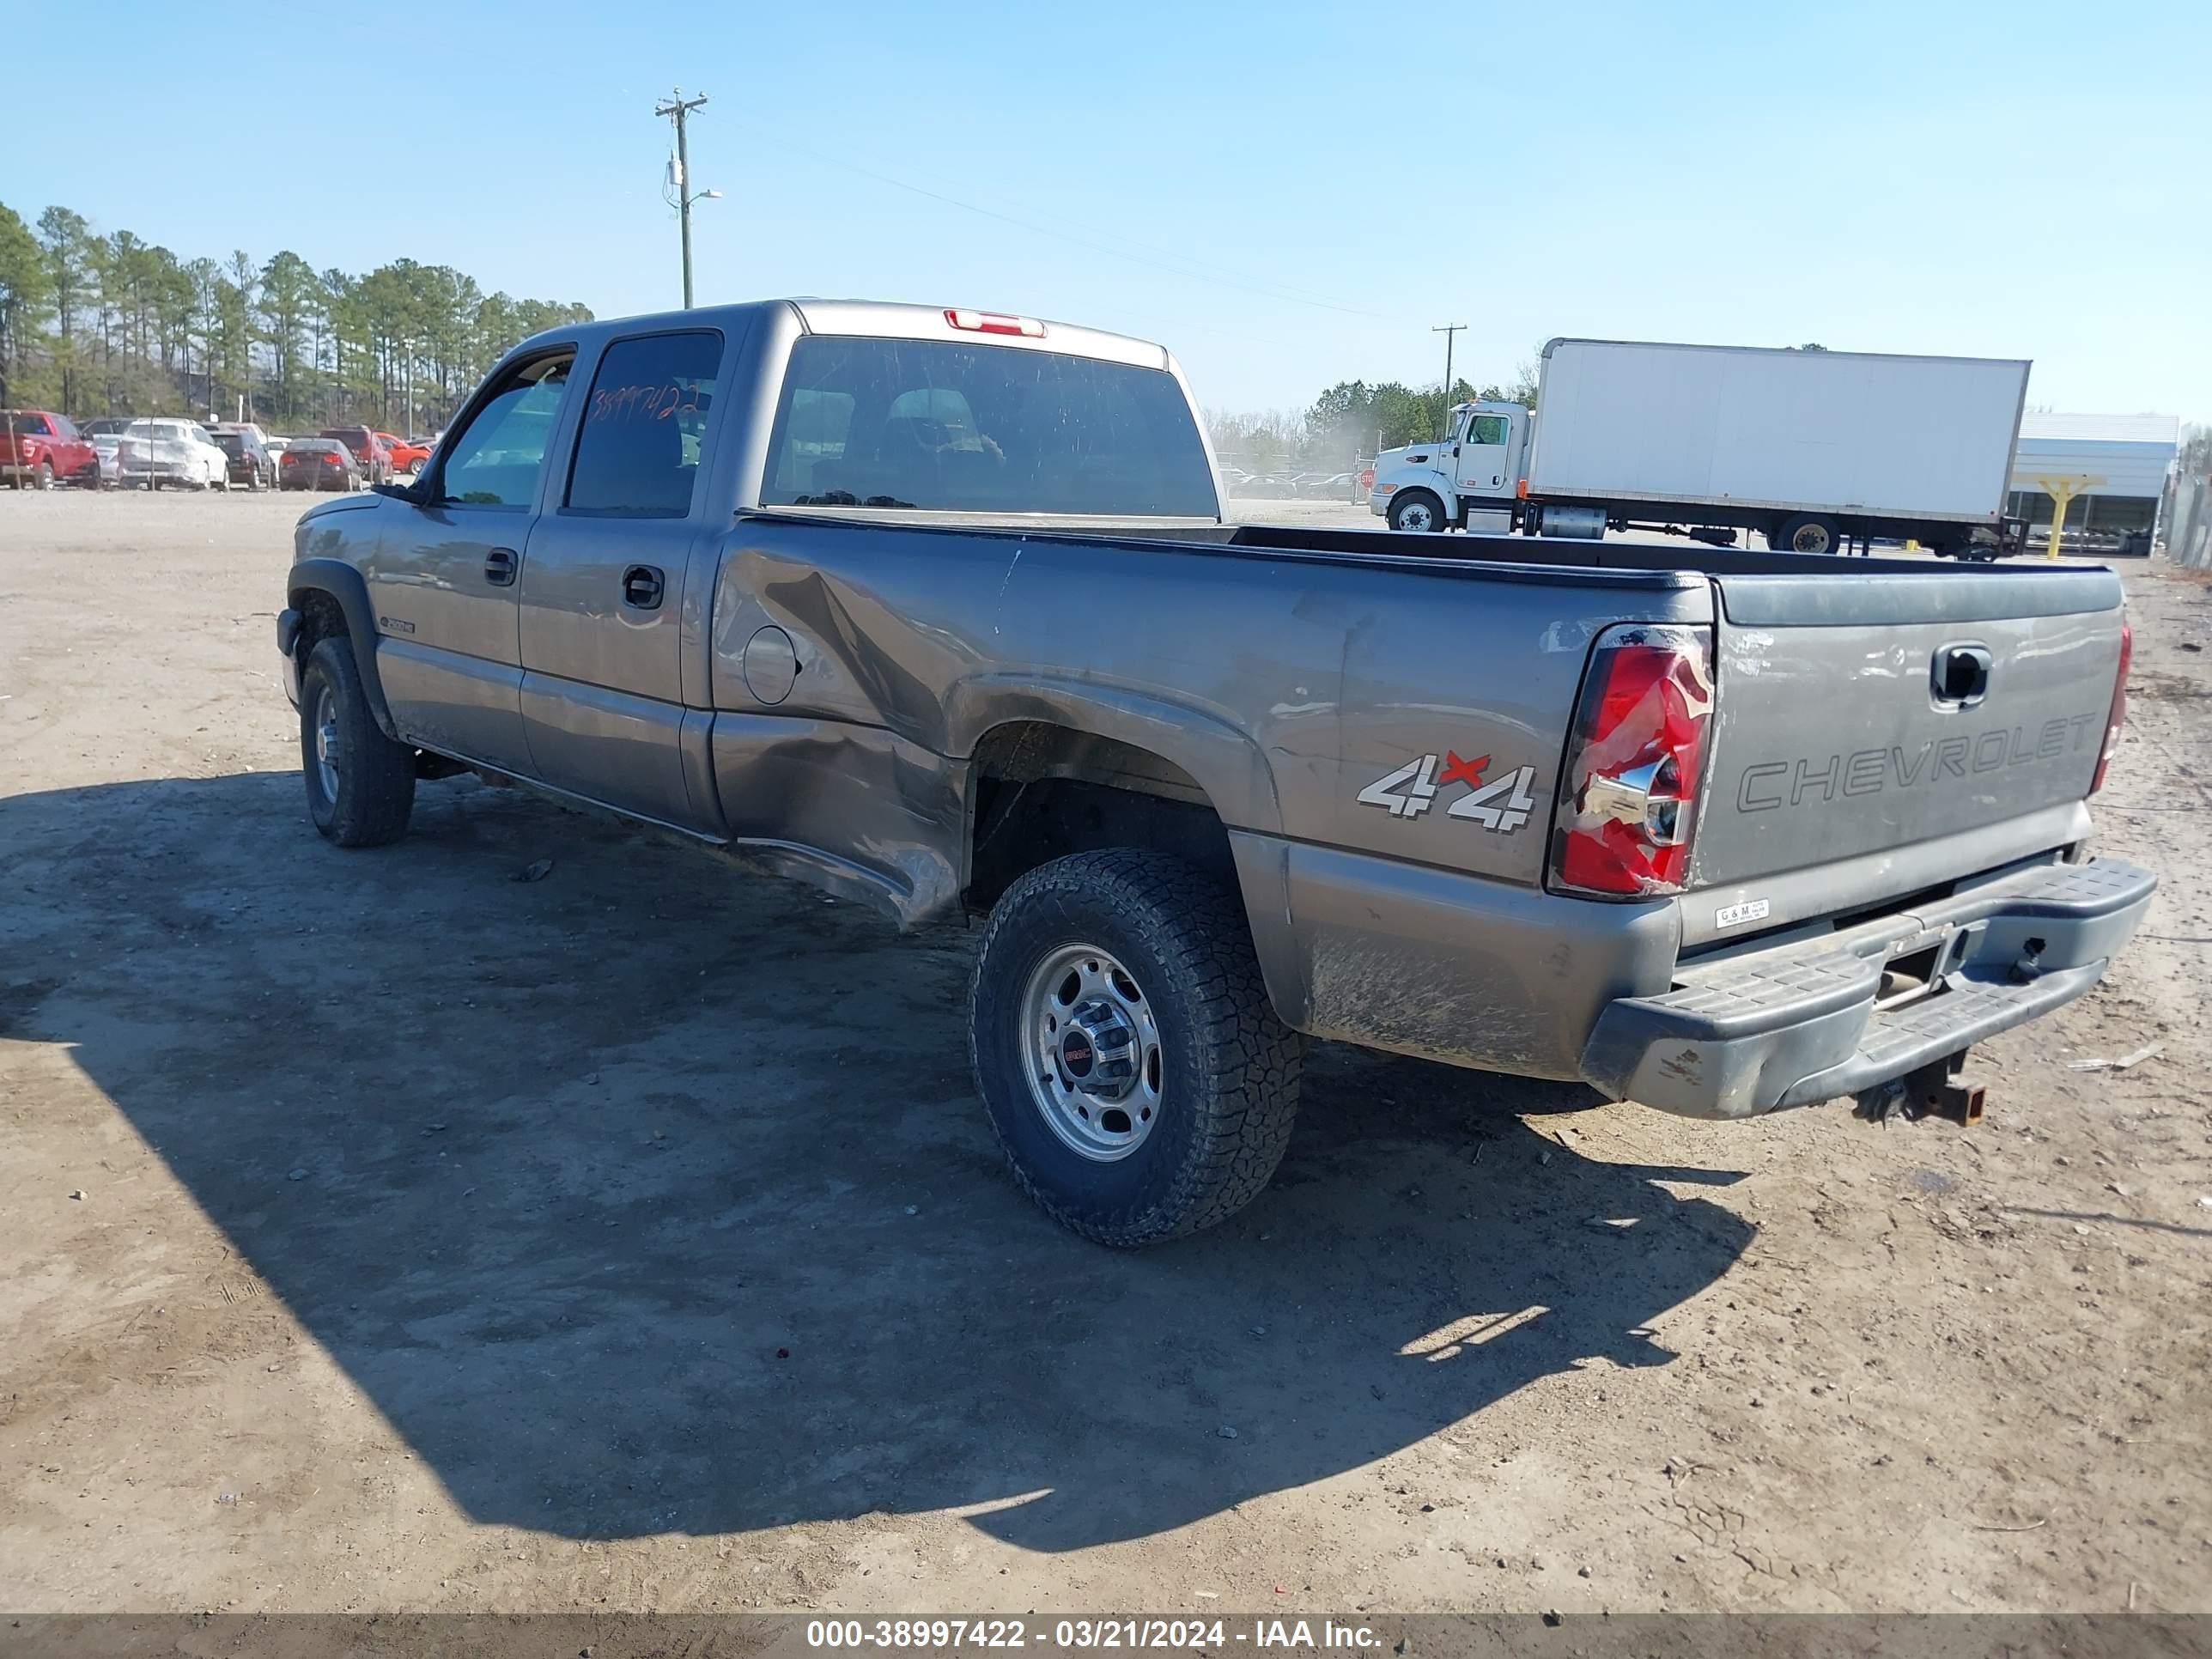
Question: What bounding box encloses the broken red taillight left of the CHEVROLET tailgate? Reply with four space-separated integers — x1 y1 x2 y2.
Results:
1551 623 1712 898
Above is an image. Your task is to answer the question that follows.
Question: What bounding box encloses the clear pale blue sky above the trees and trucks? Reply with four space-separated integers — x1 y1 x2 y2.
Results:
0 0 2212 420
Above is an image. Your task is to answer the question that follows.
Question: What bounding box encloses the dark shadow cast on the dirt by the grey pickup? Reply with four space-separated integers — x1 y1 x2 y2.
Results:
0 775 1752 1551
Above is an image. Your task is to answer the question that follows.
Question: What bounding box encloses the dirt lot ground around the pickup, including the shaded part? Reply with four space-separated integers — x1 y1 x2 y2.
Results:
0 493 2212 1614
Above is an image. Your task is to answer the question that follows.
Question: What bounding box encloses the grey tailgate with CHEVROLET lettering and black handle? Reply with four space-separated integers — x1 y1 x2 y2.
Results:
1683 564 2121 945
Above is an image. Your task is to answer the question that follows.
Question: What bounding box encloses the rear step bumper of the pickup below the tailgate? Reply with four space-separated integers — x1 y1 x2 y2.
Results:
1582 858 2159 1117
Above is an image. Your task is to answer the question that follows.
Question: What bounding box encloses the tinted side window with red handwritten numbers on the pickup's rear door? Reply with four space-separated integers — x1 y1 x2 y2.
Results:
564 330 721 518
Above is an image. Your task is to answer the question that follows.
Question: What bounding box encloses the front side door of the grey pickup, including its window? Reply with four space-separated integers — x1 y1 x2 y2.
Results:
365 347 575 776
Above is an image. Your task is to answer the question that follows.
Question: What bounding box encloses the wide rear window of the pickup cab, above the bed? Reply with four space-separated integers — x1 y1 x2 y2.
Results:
761 334 1218 518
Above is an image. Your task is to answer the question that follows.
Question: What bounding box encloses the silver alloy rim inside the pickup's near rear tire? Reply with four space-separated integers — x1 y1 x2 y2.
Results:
1020 945 1161 1164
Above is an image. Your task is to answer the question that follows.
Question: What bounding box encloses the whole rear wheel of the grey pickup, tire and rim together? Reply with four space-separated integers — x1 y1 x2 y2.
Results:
969 848 1303 1248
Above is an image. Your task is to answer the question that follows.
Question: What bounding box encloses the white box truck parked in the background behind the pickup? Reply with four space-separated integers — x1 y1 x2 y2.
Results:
1367 341 2028 557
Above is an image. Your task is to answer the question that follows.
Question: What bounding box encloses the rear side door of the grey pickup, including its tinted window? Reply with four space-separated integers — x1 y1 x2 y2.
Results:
522 327 723 830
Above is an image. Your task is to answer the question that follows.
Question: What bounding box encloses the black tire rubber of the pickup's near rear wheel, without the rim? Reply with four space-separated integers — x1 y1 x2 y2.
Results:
969 848 1303 1249
